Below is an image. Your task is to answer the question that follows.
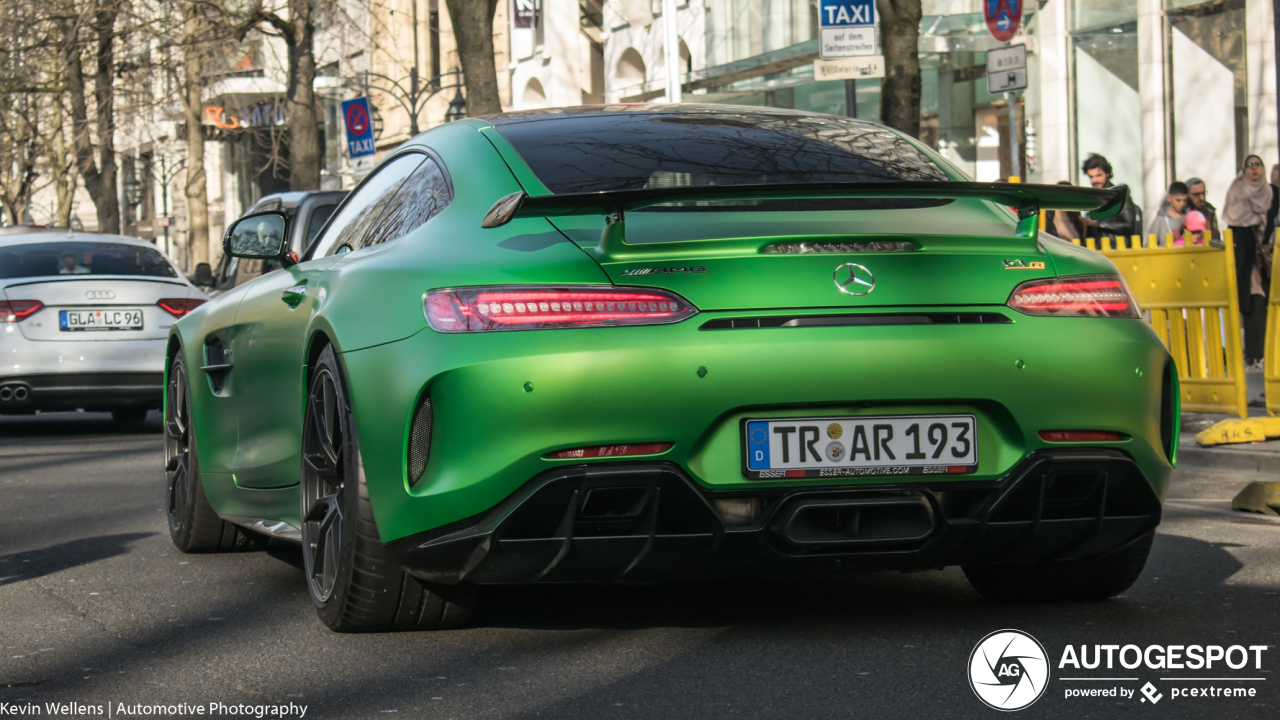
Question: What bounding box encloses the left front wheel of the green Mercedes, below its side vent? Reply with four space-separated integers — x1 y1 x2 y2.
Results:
164 352 268 552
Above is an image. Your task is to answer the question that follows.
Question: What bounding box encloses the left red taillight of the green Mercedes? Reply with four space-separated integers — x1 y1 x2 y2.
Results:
422 286 698 333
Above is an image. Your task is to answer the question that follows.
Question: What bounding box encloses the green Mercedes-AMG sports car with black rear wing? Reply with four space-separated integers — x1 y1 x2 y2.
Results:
165 105 1178 632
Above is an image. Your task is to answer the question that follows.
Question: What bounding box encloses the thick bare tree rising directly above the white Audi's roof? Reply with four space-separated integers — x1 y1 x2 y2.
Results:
56 0 123 233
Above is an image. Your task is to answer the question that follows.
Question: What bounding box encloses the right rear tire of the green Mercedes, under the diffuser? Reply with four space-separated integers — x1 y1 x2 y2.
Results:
964 529 1156 602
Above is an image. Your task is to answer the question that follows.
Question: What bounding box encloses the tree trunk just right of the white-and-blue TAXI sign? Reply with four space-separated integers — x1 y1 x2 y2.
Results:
876 0 923 137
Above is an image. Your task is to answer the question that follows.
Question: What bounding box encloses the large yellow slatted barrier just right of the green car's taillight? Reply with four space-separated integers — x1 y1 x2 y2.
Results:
1076 231 1244 418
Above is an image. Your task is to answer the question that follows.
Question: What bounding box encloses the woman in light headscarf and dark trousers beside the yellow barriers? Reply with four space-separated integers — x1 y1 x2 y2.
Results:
1222 155 1271 363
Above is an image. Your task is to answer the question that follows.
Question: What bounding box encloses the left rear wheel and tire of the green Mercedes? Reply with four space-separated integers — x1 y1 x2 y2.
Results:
298 346 475 633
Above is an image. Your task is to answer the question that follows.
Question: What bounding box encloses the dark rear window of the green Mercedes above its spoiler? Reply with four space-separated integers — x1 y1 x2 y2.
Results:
494 109 950 198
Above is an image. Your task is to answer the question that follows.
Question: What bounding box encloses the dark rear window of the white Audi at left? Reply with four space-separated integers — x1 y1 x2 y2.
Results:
0 242 178 278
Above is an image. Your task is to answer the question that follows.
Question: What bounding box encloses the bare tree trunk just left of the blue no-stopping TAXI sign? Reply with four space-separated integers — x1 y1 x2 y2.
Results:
236 0 324 190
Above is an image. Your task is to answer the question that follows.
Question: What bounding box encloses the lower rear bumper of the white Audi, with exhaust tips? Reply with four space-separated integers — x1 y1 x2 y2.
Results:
0 338 165 414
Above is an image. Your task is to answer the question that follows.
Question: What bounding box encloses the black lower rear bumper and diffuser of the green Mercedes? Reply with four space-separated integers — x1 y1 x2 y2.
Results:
387 448 1161 584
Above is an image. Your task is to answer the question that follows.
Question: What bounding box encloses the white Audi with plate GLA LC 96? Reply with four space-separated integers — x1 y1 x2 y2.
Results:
0 229 206 421
